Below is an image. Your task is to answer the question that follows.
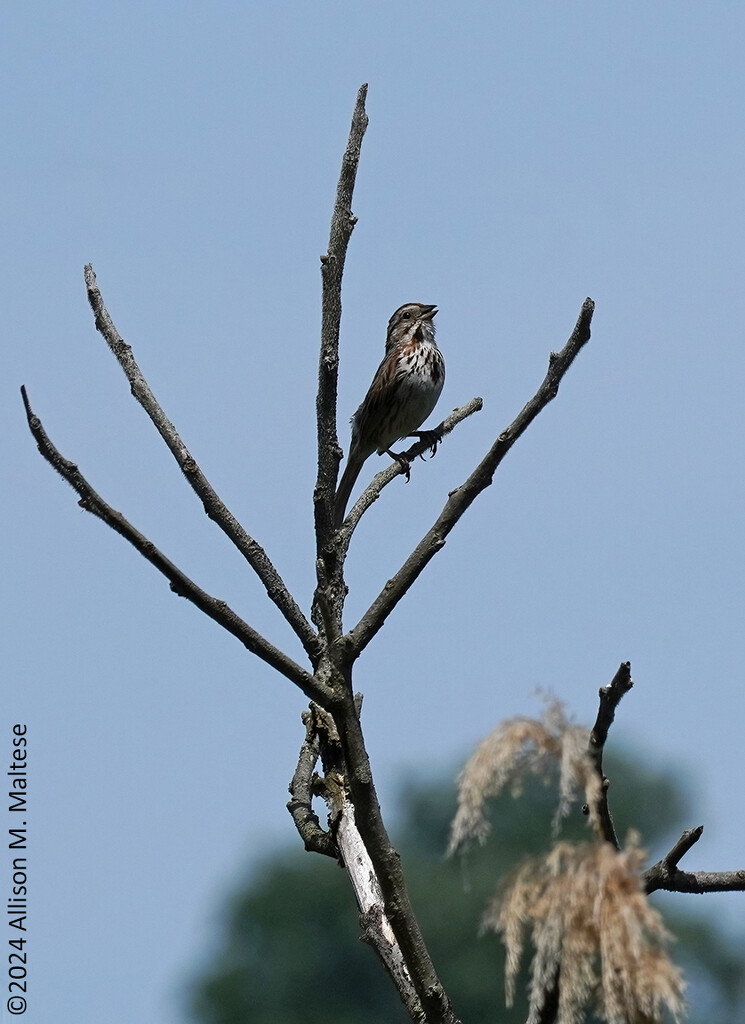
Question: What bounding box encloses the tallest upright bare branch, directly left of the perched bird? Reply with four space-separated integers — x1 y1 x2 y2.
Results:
313 85 367 558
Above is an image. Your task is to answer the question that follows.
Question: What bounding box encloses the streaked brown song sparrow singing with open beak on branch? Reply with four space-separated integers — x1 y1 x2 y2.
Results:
335 302 445 523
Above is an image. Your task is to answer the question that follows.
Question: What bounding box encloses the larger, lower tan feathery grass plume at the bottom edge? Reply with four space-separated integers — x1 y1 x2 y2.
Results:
483 835 685 1024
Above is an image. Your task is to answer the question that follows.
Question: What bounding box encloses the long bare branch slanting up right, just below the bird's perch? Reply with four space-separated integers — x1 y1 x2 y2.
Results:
344 299 595 660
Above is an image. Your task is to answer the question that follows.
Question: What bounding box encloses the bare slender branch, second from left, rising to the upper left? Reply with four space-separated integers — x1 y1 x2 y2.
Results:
84 264 320 665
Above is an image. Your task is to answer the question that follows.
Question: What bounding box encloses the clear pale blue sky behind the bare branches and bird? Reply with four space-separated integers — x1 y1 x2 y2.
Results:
0 0 745 1024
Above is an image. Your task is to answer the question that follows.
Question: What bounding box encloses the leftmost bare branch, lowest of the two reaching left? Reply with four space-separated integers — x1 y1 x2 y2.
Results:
20 387 327 700
